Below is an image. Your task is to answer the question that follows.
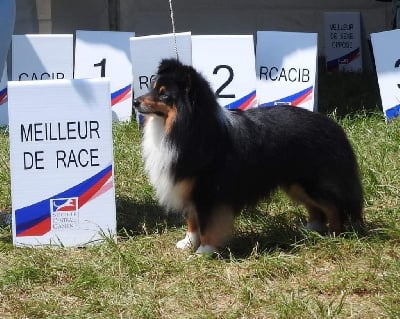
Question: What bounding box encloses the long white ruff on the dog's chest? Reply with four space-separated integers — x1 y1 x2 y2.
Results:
142 116 184 211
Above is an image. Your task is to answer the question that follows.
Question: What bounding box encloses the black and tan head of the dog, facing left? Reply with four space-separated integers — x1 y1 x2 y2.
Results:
133 59 215 132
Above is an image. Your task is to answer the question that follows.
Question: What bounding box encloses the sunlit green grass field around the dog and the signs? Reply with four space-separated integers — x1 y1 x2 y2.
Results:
0 75 400 318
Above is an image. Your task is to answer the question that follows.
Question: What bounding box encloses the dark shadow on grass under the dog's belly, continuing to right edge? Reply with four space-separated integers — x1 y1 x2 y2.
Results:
221 210 400 260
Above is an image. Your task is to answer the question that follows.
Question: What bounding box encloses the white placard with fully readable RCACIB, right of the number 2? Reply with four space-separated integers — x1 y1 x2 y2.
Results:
256 31 318 111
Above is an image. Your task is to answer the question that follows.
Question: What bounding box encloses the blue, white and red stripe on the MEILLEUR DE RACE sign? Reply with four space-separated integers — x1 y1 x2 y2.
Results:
15 165 113 237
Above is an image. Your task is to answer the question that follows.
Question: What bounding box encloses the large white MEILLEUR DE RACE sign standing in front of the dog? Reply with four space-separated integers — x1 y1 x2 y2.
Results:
8 78 116 246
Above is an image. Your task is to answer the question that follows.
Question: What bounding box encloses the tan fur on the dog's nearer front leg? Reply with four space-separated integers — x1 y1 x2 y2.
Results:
196 205 234 254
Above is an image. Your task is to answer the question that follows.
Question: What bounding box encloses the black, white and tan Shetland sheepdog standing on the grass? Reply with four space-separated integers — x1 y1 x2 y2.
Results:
133 59 363 253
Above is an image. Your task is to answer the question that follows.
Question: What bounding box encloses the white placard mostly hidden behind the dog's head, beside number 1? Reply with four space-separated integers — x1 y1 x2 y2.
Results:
130 32 192 96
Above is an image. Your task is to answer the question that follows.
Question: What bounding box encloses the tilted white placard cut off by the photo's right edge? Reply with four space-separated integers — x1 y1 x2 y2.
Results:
371 29 400 121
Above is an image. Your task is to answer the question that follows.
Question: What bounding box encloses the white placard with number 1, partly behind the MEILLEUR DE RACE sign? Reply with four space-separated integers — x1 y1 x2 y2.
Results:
74 30 135 121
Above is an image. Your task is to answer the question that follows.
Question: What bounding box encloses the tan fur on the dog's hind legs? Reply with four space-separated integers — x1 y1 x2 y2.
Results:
284 184 341 234
